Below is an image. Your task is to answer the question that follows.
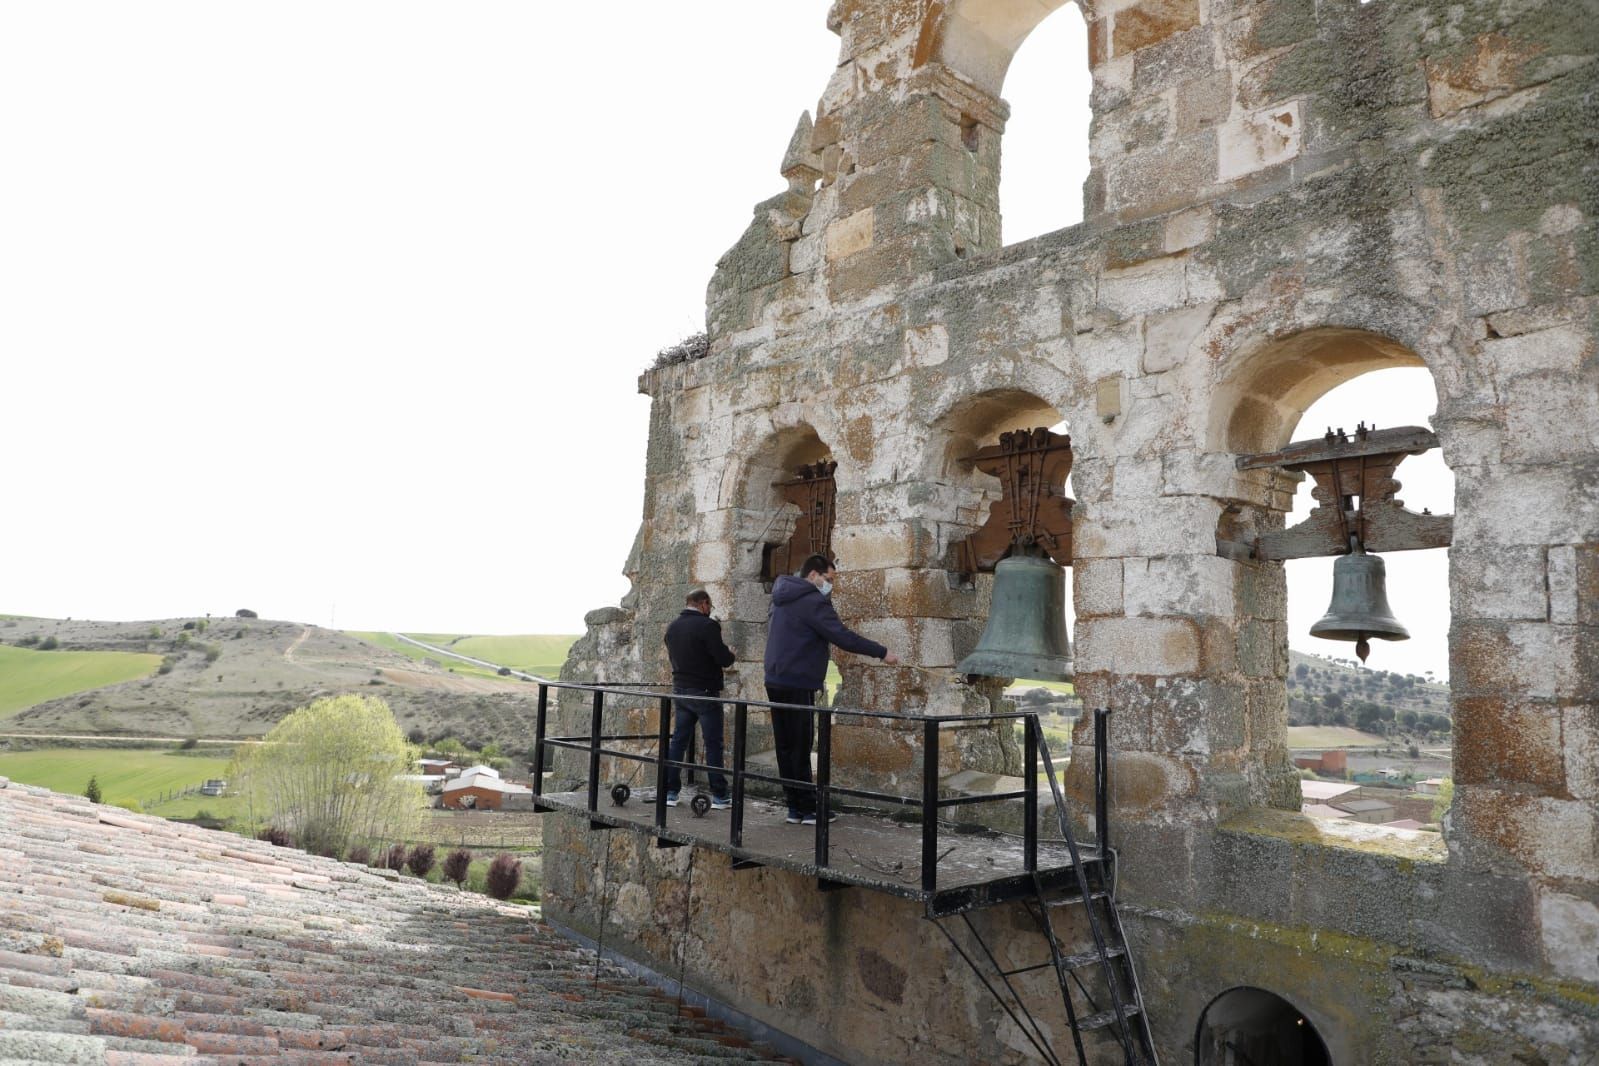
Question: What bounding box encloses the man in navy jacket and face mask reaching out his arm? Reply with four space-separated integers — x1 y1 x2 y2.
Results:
766 555 899 825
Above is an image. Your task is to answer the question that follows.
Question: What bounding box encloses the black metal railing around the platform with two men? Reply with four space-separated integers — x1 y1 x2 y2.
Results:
529 676 1108 893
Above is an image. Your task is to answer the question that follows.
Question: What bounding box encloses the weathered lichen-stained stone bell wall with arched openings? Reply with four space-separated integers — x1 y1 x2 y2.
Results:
547 0 1599 1064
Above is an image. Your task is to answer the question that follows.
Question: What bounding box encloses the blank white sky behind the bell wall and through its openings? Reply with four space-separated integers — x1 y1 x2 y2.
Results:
0 0 1452 673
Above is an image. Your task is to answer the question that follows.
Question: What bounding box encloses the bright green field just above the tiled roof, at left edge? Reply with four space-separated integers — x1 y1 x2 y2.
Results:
0 748 229 817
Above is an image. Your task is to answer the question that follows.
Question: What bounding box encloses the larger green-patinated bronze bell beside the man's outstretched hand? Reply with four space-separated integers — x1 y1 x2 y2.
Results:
955 550 1071 681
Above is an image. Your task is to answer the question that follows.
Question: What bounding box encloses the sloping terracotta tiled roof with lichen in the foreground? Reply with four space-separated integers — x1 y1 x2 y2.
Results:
0 777 786 1066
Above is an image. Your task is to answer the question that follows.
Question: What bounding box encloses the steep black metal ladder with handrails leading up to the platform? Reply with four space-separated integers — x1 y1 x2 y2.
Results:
935 710 1159 1066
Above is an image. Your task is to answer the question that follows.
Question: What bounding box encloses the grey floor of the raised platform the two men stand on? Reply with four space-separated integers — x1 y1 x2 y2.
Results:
534 791 1105 917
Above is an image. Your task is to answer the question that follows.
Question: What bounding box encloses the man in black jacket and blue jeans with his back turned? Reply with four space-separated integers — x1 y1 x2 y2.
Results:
667 588 732 810
